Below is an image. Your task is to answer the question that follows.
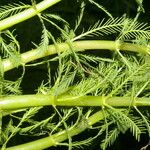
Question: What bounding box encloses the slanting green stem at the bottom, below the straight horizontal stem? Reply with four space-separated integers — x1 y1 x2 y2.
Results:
6 111 104 150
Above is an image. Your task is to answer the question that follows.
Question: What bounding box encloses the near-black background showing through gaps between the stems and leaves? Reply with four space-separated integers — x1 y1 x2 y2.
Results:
0 0 150 150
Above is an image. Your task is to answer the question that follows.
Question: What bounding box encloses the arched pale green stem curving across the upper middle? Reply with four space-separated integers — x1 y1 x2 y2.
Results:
2 40 149 71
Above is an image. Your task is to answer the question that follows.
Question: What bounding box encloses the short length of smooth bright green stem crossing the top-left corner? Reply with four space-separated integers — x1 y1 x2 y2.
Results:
0 0 61 31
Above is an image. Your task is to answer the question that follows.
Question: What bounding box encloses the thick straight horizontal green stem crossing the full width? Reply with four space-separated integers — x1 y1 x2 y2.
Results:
0 94 150 111
